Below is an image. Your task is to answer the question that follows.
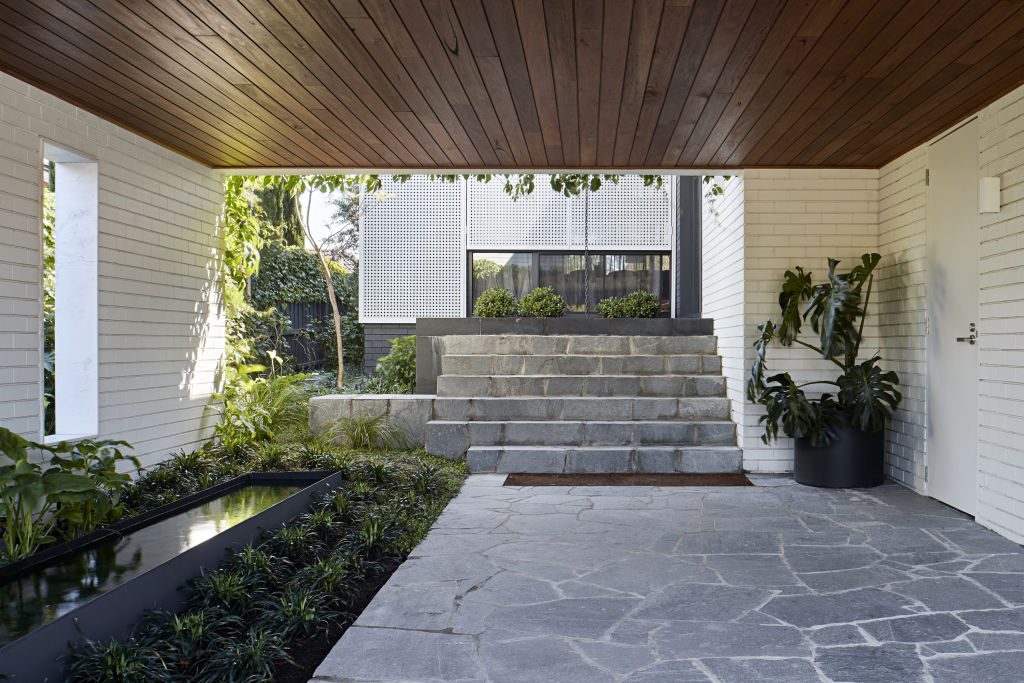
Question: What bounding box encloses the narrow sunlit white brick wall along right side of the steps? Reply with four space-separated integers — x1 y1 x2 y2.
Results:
700 176 748 454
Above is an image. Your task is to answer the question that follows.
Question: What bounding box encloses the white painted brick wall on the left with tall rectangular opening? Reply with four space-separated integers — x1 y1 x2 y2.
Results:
0 74 224 465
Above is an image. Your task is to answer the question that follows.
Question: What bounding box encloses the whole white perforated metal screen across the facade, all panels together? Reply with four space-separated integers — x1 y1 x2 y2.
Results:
359 175 673 323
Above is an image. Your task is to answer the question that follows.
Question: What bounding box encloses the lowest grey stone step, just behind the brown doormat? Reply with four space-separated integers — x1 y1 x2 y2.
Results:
466 445 743 473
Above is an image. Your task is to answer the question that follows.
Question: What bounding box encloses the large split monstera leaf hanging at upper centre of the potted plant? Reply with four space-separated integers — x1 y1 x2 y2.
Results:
804 258 863 358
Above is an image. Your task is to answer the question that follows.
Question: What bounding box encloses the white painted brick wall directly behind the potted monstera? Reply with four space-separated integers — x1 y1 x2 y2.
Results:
740 169 879 472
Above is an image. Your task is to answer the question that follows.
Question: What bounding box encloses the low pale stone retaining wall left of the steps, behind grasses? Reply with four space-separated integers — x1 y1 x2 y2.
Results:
309 393 436 445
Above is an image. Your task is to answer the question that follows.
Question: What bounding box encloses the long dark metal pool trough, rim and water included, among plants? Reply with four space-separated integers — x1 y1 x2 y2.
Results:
0 472 341 680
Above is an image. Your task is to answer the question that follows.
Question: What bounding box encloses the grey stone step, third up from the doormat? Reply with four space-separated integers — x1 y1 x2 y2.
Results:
433 396 729 421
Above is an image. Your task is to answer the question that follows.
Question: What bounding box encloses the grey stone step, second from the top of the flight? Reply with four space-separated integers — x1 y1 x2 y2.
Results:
440 353 722 376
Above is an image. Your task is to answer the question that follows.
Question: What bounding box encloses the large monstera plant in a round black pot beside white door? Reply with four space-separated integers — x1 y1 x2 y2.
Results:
746 254 902 487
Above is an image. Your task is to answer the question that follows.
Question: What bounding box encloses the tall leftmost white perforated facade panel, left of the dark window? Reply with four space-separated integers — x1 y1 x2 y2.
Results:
359 176 466 323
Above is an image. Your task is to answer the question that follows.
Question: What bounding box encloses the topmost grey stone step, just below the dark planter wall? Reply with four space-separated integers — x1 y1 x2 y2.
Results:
444 335 718 355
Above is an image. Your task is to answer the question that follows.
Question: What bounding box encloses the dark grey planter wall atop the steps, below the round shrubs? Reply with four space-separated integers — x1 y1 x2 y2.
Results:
413 316 715 393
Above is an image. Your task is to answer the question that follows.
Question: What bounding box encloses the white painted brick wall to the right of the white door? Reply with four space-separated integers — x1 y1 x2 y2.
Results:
976 87 1024 543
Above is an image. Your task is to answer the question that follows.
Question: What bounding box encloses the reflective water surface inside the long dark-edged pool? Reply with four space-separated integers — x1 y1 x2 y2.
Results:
0 486 300 646
